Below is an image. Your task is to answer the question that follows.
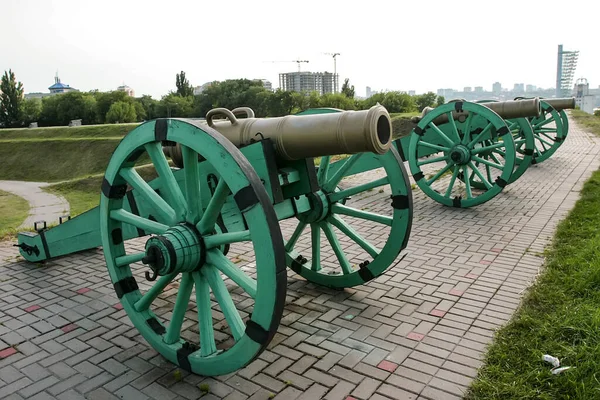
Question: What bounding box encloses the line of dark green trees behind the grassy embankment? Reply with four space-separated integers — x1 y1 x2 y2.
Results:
0 70 444 127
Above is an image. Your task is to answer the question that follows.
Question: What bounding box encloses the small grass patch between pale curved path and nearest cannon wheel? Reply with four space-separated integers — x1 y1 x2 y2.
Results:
43 166 157 217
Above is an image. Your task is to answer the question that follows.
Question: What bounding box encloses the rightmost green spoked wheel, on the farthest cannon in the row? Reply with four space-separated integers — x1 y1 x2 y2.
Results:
530 100 566 164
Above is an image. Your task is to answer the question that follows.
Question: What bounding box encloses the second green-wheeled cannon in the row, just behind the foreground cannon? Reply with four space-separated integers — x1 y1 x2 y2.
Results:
305 98 542 208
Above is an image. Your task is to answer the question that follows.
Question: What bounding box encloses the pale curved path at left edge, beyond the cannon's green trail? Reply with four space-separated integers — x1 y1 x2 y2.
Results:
0 181 69 228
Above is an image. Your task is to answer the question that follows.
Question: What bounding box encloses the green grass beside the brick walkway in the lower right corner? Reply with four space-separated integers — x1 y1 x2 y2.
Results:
467 113 600 399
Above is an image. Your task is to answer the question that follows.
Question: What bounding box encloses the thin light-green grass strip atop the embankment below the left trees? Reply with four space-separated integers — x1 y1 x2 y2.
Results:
0 123 138 140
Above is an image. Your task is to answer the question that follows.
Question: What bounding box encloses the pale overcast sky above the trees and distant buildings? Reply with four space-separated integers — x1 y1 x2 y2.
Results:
0 0 600 98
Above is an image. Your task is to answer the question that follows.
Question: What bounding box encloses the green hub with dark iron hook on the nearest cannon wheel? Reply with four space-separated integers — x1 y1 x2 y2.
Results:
142 225 206 277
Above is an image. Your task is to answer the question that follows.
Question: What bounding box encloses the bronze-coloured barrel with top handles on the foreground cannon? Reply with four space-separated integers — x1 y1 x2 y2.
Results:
164 105 392 167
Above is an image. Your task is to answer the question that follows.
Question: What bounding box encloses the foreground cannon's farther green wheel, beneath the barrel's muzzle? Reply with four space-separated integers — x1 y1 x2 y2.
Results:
286 148 412 288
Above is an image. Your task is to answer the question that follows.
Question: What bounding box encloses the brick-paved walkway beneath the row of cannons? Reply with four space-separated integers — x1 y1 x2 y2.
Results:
0 116 600 400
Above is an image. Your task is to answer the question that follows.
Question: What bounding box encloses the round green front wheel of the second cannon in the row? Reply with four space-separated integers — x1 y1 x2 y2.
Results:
408 102 516 207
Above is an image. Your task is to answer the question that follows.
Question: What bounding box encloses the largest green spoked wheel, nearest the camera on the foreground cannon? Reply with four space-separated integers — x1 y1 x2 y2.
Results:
100 119 286 375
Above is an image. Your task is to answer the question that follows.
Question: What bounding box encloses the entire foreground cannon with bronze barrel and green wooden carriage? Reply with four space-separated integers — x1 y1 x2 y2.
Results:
18 106 413 375
